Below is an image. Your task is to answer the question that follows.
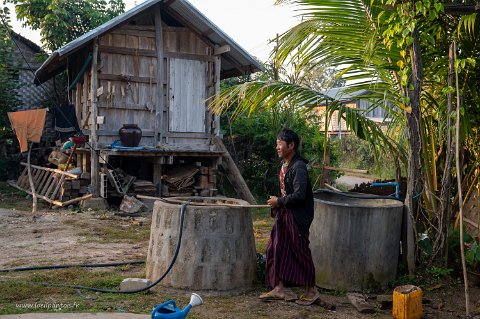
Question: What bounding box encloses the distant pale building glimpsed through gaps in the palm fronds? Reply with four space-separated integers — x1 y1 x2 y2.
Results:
316 87 390 137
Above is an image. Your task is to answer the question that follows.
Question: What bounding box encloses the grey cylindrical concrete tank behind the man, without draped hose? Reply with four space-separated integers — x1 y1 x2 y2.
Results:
310 190 403 291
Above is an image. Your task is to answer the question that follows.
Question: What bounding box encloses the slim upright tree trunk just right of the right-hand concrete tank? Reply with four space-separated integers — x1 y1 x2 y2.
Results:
404 29 423 274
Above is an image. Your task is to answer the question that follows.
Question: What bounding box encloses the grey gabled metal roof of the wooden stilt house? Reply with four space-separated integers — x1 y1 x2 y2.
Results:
35 0 264 84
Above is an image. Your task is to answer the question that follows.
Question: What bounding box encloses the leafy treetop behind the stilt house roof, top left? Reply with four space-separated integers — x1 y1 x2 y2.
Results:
8 0 125 51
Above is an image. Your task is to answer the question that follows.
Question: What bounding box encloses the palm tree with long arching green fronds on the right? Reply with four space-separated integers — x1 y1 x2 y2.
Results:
211 0 480 269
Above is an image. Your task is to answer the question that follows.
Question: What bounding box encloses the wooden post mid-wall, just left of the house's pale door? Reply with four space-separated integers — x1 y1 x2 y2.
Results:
158 4 165 146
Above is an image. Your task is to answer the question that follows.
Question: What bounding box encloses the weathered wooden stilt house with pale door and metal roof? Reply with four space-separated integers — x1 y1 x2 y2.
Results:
36 0 262 204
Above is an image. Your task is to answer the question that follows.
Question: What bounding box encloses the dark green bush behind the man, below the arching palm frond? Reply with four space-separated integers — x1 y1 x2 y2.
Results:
222 110 330 201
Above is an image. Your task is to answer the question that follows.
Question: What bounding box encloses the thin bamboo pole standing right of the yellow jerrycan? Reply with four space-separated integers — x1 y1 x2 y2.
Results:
453 41 470 317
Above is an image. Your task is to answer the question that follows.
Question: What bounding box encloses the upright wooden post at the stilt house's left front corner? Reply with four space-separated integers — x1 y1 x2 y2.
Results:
87 39 99 198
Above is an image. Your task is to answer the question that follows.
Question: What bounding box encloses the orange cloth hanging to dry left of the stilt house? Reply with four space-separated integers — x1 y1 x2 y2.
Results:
7 109 47 152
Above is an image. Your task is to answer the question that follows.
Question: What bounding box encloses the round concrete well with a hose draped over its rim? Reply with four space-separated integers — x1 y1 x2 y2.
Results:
147 197 256 291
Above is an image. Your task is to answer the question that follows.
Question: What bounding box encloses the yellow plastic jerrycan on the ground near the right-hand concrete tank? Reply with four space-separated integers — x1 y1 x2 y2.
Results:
392 285 423 319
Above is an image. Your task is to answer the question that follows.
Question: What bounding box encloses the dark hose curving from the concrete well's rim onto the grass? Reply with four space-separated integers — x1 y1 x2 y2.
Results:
34 204 188 294
